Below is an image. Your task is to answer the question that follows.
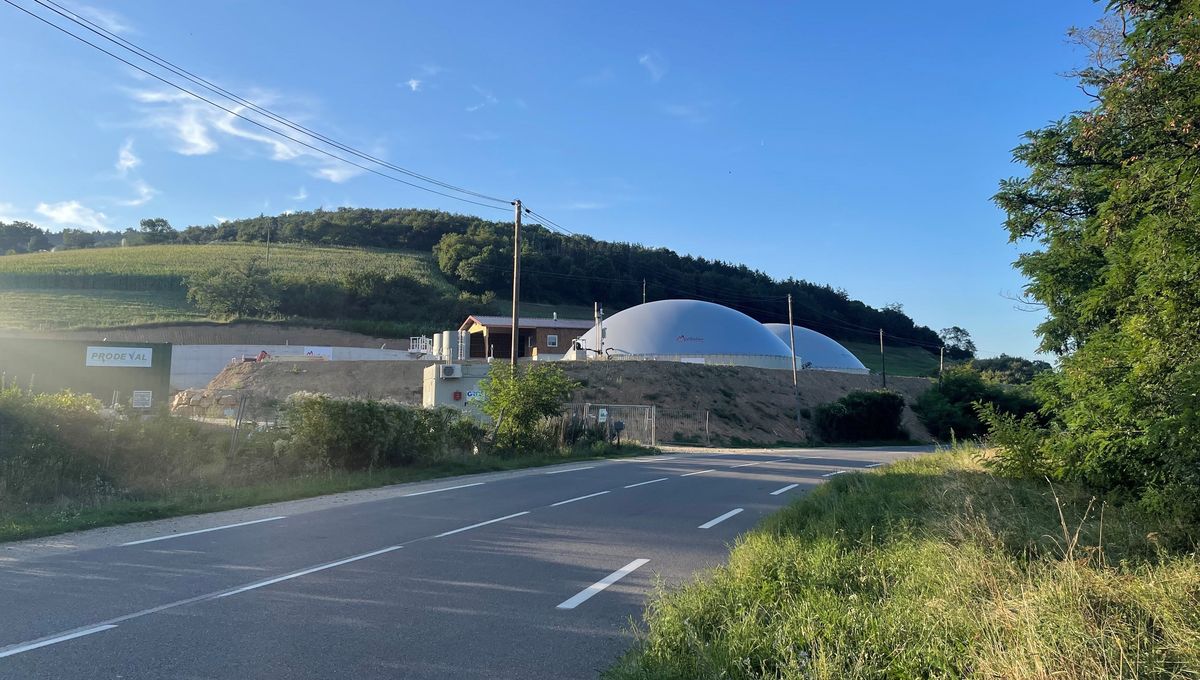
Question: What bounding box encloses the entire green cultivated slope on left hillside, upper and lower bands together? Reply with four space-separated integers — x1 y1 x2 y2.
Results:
0 243 454 330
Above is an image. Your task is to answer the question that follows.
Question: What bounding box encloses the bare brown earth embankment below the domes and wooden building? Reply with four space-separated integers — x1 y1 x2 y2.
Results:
196 361 930 445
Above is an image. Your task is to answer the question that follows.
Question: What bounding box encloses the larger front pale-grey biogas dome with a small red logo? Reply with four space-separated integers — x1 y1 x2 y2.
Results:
580 300 792 368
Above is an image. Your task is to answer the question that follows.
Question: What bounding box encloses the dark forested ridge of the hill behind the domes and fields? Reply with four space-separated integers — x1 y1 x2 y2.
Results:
0 207 940 347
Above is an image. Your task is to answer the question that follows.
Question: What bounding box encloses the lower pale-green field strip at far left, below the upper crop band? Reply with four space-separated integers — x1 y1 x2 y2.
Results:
0 290 205 330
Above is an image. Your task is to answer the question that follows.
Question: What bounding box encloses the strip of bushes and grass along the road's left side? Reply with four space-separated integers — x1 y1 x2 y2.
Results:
0 367 648 541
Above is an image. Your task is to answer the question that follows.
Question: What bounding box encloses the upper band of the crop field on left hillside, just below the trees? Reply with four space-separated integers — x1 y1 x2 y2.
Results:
0 243 451 291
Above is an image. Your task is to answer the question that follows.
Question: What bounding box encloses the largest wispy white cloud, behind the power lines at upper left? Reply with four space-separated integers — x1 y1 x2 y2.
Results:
130 90 364 182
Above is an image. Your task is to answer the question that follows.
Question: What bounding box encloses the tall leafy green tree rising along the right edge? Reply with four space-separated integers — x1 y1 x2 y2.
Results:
996 0 1200 531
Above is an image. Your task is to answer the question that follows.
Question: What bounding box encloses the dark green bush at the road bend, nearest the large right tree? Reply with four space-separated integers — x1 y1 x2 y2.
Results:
912 367 1038 440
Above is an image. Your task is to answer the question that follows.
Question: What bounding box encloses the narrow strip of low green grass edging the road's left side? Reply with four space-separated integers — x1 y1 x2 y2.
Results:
0 445 656 543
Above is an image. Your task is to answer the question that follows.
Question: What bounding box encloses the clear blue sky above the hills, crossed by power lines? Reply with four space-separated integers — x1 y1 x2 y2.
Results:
0 0 1103 356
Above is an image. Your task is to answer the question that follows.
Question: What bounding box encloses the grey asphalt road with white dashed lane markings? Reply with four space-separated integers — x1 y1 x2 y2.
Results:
0 449 920 679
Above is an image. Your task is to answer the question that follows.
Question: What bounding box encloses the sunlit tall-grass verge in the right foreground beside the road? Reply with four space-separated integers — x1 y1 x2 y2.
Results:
607 450 1200 680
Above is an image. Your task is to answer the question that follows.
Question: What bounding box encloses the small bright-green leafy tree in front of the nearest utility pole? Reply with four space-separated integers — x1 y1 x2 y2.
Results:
479 363 578 452
